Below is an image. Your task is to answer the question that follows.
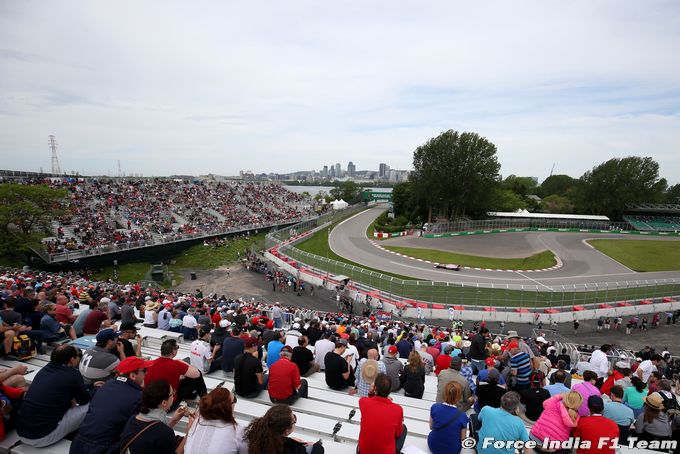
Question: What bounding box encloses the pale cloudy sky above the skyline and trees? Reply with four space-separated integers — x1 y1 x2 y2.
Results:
0 0 680 183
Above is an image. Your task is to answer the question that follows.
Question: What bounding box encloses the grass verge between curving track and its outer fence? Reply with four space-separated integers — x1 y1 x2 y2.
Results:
286 221 680 310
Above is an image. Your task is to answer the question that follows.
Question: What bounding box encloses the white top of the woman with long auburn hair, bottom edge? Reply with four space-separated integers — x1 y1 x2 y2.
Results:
184 417 248 454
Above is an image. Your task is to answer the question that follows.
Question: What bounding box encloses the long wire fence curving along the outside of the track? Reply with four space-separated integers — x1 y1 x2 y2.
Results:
267 210 680 310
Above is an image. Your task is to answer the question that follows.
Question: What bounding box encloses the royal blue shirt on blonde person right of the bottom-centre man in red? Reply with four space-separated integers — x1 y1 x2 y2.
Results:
427 403 468 454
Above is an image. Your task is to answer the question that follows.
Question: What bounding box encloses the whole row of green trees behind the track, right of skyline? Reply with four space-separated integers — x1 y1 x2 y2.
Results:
392 130 680 223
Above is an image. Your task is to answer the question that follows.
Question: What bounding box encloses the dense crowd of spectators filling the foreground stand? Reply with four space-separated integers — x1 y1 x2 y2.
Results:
0 270 680 454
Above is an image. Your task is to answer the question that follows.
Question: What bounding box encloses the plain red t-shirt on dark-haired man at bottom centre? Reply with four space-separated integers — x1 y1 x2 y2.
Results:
359 396 404 454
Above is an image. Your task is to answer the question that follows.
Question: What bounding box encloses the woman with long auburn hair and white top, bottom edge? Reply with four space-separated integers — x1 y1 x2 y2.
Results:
180 388 248 454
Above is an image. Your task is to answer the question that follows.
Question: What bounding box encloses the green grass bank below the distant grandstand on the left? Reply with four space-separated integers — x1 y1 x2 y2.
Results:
94 232 266 283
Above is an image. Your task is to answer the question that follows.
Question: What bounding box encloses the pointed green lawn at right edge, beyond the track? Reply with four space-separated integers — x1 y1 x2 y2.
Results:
588 240 680 271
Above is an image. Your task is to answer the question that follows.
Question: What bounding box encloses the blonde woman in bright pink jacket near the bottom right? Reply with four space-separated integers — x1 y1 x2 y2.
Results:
529 391 583 452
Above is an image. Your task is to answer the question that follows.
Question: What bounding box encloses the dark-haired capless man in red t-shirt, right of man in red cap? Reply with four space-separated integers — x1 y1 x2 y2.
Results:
144 339 208 410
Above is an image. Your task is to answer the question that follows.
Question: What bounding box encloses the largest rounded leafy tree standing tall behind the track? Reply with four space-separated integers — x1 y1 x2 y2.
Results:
409 130 500 221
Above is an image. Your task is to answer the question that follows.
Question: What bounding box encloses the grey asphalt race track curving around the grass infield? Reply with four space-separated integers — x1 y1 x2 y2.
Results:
329 207 680 290
